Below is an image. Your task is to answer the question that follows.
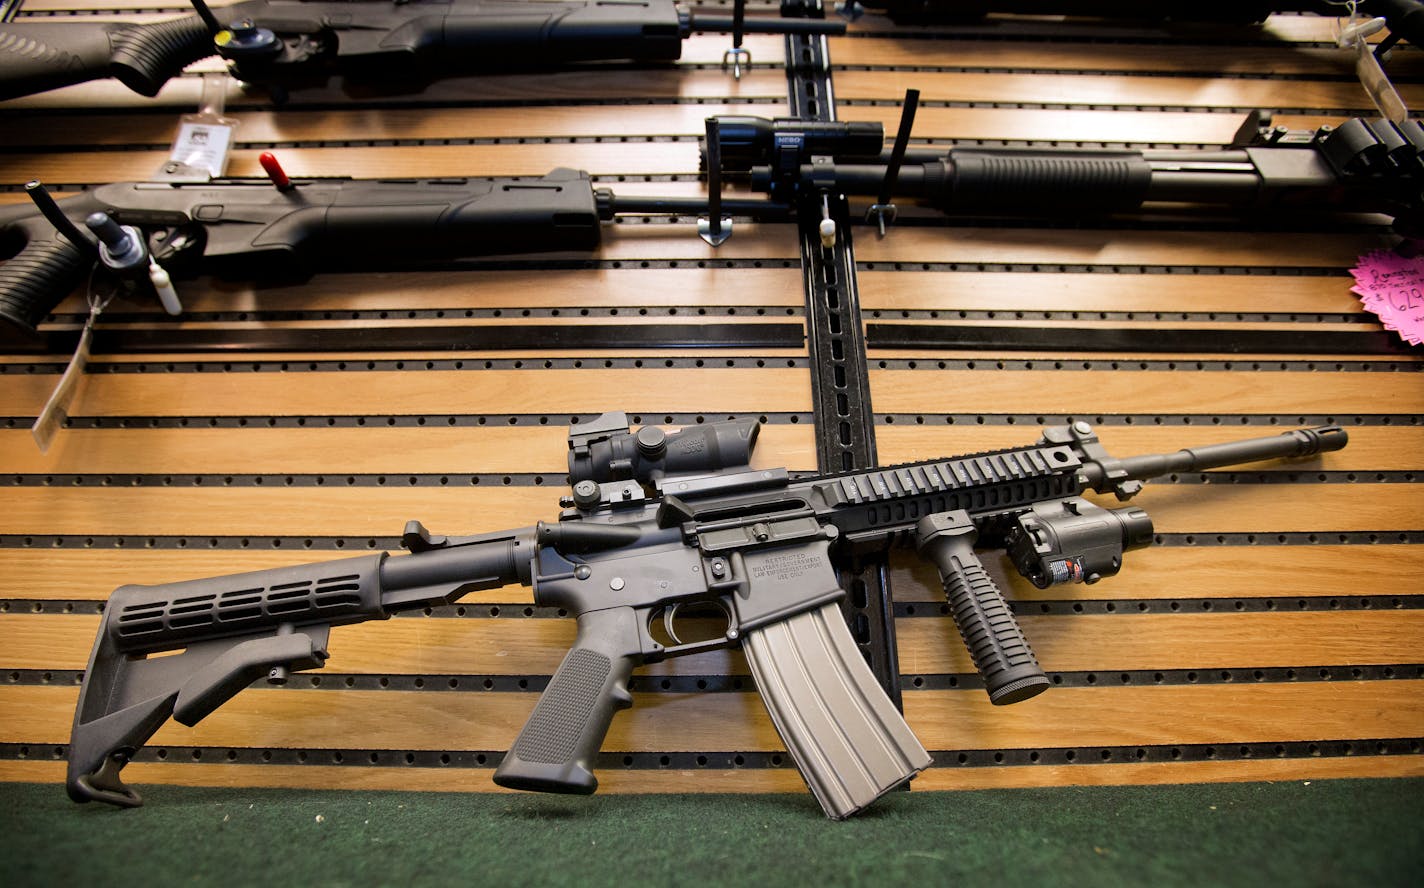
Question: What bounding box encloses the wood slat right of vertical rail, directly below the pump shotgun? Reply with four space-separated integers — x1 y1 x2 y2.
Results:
856 226 1391 270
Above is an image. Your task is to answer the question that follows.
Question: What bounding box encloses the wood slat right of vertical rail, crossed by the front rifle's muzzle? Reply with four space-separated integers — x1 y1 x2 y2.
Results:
871 424 1424 472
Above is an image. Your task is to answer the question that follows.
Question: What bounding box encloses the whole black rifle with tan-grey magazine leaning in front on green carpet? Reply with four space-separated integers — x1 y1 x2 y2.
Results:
67 413 1347 820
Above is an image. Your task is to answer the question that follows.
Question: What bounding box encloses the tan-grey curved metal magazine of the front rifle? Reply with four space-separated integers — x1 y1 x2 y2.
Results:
742 603 930 820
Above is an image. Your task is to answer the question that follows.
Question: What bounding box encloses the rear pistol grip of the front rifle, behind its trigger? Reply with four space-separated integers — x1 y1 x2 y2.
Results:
494 608 641 796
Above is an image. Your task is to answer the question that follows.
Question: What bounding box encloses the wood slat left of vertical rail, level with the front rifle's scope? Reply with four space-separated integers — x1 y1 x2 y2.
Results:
0 424 816 475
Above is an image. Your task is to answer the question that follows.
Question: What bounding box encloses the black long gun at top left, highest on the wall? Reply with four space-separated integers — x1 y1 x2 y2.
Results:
0 0 846 100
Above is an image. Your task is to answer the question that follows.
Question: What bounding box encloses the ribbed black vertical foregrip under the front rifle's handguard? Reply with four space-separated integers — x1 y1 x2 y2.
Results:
916 511 1048 706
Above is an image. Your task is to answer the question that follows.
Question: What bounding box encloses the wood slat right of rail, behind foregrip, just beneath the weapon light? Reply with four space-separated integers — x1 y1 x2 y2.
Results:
888 540 1424 603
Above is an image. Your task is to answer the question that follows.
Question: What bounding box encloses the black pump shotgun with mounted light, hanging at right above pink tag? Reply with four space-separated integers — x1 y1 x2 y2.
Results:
718 114 1424 233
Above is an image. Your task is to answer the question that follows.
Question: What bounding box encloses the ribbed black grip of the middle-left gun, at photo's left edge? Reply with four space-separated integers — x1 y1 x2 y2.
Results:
0 219 90 337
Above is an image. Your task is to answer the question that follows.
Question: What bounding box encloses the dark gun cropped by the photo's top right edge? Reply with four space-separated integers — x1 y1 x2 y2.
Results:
843 0 1424 46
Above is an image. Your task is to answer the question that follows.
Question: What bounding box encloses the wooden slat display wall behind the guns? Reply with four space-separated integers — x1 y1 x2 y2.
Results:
0 0 1424 791
